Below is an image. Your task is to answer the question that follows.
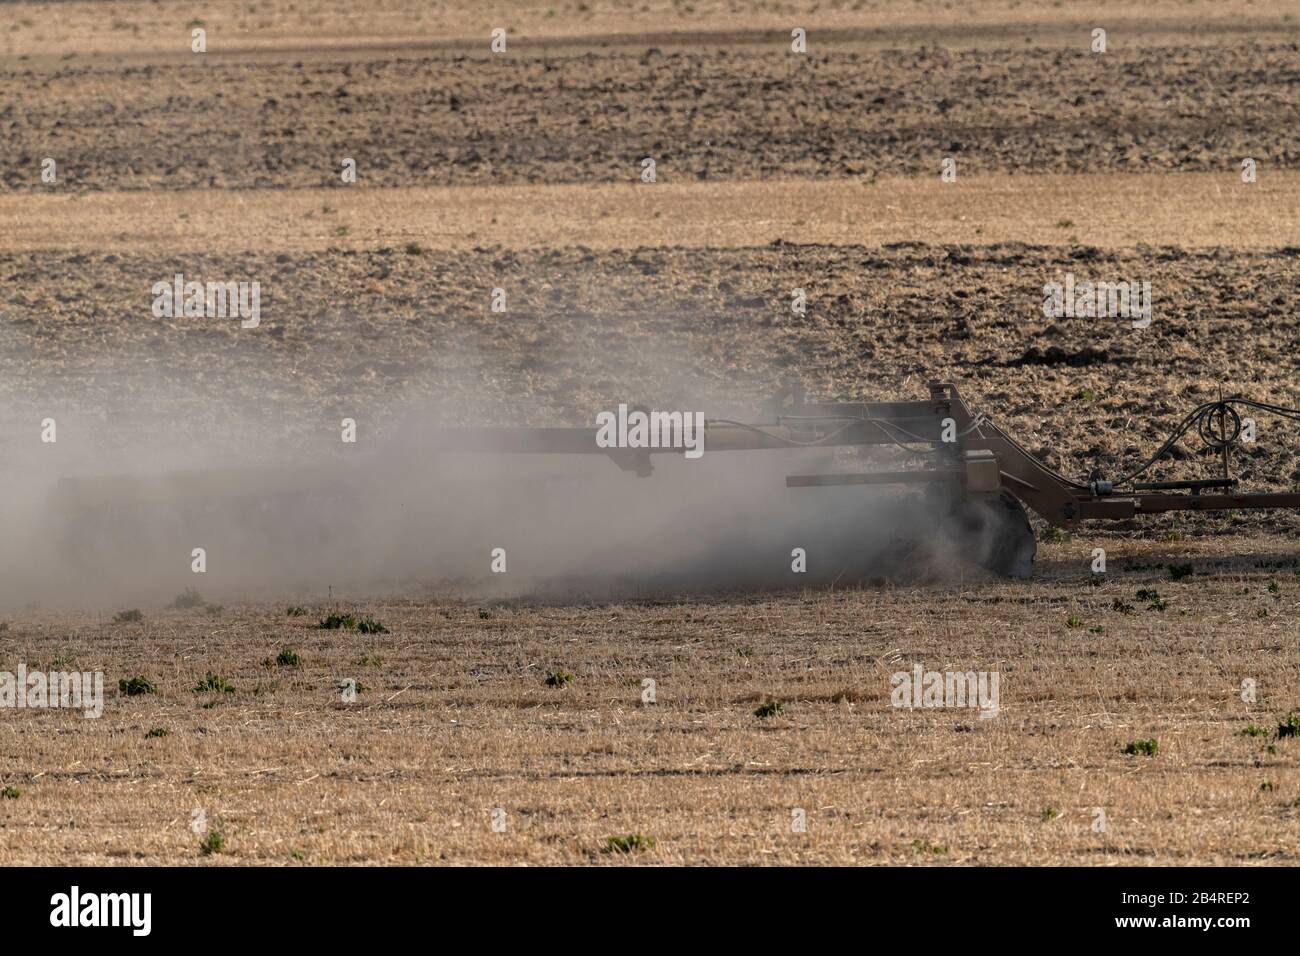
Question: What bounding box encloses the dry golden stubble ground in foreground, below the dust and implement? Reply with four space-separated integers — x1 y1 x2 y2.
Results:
0 538 1300 865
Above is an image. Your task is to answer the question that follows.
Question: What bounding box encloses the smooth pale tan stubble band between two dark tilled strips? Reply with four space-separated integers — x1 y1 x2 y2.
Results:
0 171 1300 254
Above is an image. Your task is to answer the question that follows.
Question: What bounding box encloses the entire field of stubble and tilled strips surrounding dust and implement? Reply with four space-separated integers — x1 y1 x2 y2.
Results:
0 0 1300 864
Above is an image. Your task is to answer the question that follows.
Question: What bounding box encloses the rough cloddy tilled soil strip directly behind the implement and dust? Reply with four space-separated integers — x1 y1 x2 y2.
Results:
0 243 1300 527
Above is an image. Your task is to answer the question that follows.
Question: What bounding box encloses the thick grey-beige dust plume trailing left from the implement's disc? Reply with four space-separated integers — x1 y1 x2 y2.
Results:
0 398 982 607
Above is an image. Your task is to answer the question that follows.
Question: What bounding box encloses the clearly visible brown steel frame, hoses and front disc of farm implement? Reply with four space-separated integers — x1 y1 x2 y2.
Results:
426 382 1300 576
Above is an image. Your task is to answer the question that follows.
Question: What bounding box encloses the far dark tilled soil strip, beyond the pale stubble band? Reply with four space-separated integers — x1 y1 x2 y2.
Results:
0 40 1300 190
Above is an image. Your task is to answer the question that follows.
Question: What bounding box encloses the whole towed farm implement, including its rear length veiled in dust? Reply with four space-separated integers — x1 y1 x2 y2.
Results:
51 382 1300 578
